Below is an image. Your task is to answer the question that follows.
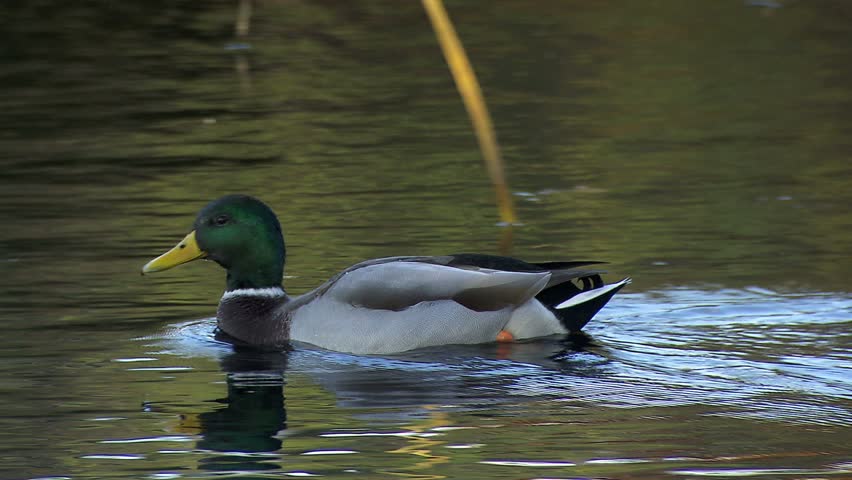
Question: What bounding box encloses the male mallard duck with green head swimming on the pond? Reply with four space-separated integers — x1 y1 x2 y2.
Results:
142 195 630 354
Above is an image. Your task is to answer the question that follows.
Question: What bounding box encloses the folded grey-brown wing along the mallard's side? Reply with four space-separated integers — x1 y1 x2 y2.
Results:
316 256 551 311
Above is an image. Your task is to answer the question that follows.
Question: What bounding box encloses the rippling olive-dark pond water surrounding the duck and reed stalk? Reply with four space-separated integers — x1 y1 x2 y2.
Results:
0 0 852 479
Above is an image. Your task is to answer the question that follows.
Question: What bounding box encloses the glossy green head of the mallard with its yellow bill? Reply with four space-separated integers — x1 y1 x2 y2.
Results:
142 195 285 290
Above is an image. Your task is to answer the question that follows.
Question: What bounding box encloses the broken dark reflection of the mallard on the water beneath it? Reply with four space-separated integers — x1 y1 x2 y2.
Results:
153 322 607 472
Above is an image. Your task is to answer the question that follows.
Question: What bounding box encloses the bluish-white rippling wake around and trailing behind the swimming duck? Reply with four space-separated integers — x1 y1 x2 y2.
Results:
146 288 852 426
